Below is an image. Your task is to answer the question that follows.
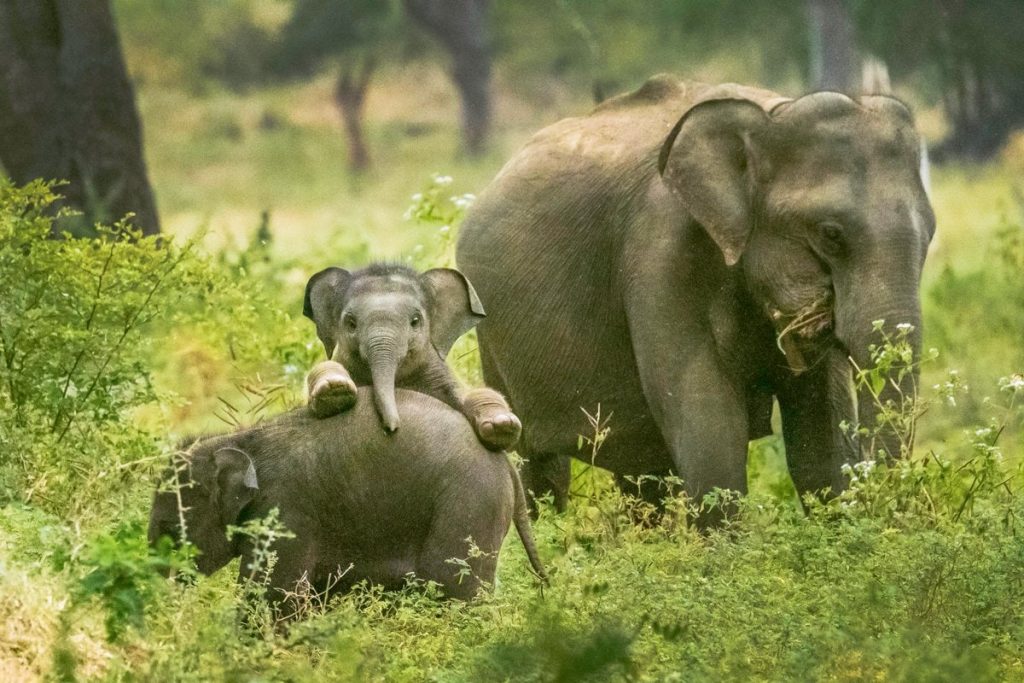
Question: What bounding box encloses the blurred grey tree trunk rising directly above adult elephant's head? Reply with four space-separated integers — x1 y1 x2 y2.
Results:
807 0 860 93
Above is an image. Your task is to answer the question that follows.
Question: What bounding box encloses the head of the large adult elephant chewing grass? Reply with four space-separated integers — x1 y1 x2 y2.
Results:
659 92 935 455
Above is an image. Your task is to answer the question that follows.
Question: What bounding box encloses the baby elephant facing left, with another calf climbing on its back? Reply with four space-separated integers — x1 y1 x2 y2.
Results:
148 388 544 616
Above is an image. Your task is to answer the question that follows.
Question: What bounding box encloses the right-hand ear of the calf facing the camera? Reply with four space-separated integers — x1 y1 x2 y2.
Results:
420 268 486 357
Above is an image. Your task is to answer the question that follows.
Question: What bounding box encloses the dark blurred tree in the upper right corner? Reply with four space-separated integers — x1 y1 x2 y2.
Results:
855 0 1024 159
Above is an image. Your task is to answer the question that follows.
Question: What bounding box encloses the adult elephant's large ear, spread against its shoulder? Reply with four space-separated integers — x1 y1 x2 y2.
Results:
657 99 769 265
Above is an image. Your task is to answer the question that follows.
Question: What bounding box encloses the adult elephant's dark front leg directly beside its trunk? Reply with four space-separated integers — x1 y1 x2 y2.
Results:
778 350 857 498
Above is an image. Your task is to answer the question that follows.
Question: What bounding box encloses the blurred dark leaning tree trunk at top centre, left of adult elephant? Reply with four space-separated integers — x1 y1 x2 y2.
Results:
404 0 490 155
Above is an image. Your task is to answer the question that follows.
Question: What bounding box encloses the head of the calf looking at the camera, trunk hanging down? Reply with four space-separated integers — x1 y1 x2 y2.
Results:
303 265 484 431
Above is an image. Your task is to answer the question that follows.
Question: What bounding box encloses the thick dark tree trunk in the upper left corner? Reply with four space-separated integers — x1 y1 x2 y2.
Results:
0 0 160 234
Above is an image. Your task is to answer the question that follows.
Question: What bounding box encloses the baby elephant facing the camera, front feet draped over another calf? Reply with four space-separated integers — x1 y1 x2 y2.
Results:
302 264 522 451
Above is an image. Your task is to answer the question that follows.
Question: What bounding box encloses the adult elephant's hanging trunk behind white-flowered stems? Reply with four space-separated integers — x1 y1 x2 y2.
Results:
837 288 922 459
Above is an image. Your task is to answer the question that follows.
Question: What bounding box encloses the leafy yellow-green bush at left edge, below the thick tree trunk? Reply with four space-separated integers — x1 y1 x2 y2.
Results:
0 182 213 518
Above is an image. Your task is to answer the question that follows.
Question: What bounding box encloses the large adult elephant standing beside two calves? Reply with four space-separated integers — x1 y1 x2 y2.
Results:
457 77 935 524
